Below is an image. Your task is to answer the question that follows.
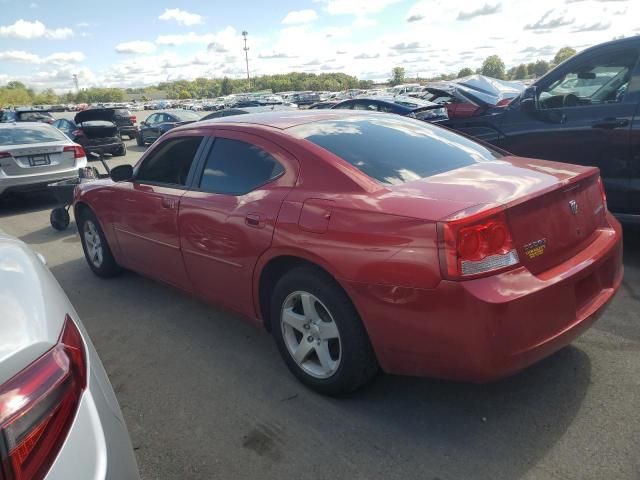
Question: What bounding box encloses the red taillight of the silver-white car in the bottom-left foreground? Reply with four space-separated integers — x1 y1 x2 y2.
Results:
0 316 87 480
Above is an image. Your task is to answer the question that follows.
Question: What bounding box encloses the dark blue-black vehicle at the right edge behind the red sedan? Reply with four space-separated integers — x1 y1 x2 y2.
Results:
445 37 640 223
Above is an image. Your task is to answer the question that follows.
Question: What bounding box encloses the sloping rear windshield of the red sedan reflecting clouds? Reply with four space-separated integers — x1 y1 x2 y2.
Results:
289 115 502 185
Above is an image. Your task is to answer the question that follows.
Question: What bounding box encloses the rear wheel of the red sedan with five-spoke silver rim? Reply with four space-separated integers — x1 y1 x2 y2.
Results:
271 267 378 395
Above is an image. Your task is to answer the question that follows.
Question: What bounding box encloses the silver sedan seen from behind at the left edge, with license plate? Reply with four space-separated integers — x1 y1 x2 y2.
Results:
0 122 87 199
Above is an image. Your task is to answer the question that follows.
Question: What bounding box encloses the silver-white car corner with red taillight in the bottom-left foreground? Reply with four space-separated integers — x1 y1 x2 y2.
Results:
0 232 139 480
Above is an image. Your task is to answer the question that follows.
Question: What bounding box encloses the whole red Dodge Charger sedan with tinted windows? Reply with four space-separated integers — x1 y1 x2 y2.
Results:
74 110 623 394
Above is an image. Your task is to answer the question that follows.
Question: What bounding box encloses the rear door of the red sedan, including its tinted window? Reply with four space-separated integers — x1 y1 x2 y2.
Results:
178 130 299 317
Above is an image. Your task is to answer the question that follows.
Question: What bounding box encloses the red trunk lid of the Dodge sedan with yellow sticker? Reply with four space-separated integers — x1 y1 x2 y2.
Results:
391 157 606 274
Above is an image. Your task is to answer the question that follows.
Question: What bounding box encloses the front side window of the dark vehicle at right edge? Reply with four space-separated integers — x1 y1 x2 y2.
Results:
540 50 638 108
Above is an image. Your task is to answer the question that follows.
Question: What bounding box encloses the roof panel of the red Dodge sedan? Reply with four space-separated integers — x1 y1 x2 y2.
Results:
195 110 380 130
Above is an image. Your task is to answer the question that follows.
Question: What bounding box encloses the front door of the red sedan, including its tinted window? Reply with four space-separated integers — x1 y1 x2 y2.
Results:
114 135 203 291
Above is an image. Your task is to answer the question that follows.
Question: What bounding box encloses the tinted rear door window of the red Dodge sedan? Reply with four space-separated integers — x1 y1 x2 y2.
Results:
200 138 284 195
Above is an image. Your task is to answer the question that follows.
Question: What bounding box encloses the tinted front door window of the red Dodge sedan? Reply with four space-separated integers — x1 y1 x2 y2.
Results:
136 137 202 185
